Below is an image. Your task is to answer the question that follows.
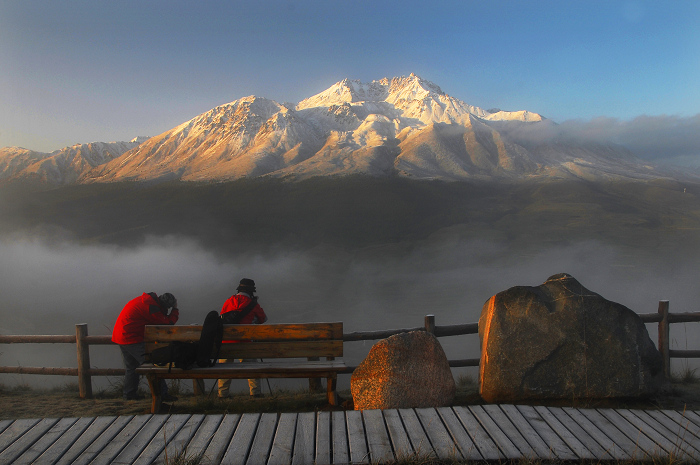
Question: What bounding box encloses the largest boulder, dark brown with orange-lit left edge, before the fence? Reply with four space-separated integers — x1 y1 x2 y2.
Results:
479 274 664 402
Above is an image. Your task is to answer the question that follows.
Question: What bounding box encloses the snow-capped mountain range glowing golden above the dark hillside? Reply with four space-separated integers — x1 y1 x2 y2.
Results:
0 74 684 183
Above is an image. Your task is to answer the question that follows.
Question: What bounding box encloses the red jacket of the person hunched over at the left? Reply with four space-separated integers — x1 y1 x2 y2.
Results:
112 292 180 344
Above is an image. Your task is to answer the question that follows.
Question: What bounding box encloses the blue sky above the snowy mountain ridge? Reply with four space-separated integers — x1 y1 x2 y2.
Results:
0 0 700 156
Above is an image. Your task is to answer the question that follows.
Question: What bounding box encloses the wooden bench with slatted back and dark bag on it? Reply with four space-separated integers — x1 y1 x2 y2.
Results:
136 323 348 413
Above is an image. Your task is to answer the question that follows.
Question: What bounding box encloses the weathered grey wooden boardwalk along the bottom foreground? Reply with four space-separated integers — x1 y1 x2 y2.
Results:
0 405 700 465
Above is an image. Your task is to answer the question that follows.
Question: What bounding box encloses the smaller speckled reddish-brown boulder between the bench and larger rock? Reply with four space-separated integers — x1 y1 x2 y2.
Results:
350 331 456 410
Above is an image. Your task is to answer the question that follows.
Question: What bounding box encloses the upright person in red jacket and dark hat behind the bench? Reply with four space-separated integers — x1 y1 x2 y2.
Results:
219 278 267 397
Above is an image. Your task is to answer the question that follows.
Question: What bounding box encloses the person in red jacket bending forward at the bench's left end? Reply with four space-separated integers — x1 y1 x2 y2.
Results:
112 292 180 402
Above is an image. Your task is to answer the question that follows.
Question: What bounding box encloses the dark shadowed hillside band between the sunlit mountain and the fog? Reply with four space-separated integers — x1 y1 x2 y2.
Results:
0 176 700 258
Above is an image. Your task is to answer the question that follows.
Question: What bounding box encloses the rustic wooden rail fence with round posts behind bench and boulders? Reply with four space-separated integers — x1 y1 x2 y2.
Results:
0 300 700 398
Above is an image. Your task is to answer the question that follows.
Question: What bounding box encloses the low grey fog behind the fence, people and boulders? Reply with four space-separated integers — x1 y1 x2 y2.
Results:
0 232 700 389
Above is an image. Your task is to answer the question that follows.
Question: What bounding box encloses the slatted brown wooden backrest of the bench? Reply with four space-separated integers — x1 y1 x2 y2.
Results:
144 322 343 359
